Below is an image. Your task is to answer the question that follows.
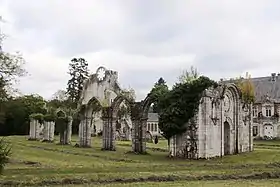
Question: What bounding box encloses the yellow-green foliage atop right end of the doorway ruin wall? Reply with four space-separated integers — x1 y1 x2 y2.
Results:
236 72 255 103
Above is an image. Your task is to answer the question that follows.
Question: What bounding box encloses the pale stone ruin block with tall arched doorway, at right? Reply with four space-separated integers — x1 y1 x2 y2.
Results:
170 84 253 159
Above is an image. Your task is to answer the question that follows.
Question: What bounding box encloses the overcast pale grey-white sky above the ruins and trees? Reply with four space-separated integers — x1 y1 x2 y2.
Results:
0 0 280 99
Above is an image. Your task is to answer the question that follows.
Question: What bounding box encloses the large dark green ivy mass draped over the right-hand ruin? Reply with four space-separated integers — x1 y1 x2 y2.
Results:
159 76 217 139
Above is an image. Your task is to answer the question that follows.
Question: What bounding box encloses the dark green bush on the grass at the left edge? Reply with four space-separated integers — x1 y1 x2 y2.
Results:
0 138 11 174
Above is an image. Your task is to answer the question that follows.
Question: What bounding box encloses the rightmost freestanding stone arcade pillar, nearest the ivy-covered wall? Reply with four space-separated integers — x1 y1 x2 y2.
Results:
131 102 147 154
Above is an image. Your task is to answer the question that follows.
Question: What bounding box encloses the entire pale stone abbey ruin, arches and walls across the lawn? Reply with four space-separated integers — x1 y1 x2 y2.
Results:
30 67 253 159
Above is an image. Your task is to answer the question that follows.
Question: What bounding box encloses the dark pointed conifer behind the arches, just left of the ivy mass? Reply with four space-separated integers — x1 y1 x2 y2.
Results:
149 78 169 113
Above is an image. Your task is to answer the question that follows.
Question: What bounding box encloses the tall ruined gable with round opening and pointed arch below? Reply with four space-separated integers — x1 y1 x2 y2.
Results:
76 67 132 150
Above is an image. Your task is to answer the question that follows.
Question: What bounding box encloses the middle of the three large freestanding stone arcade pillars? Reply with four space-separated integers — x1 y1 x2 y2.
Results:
102 107 116 151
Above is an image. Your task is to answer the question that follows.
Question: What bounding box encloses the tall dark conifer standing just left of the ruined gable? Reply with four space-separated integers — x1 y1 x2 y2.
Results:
67 58 89 108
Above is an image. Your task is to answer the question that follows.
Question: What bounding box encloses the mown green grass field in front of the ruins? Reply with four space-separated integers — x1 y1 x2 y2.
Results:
0 136 280 187
